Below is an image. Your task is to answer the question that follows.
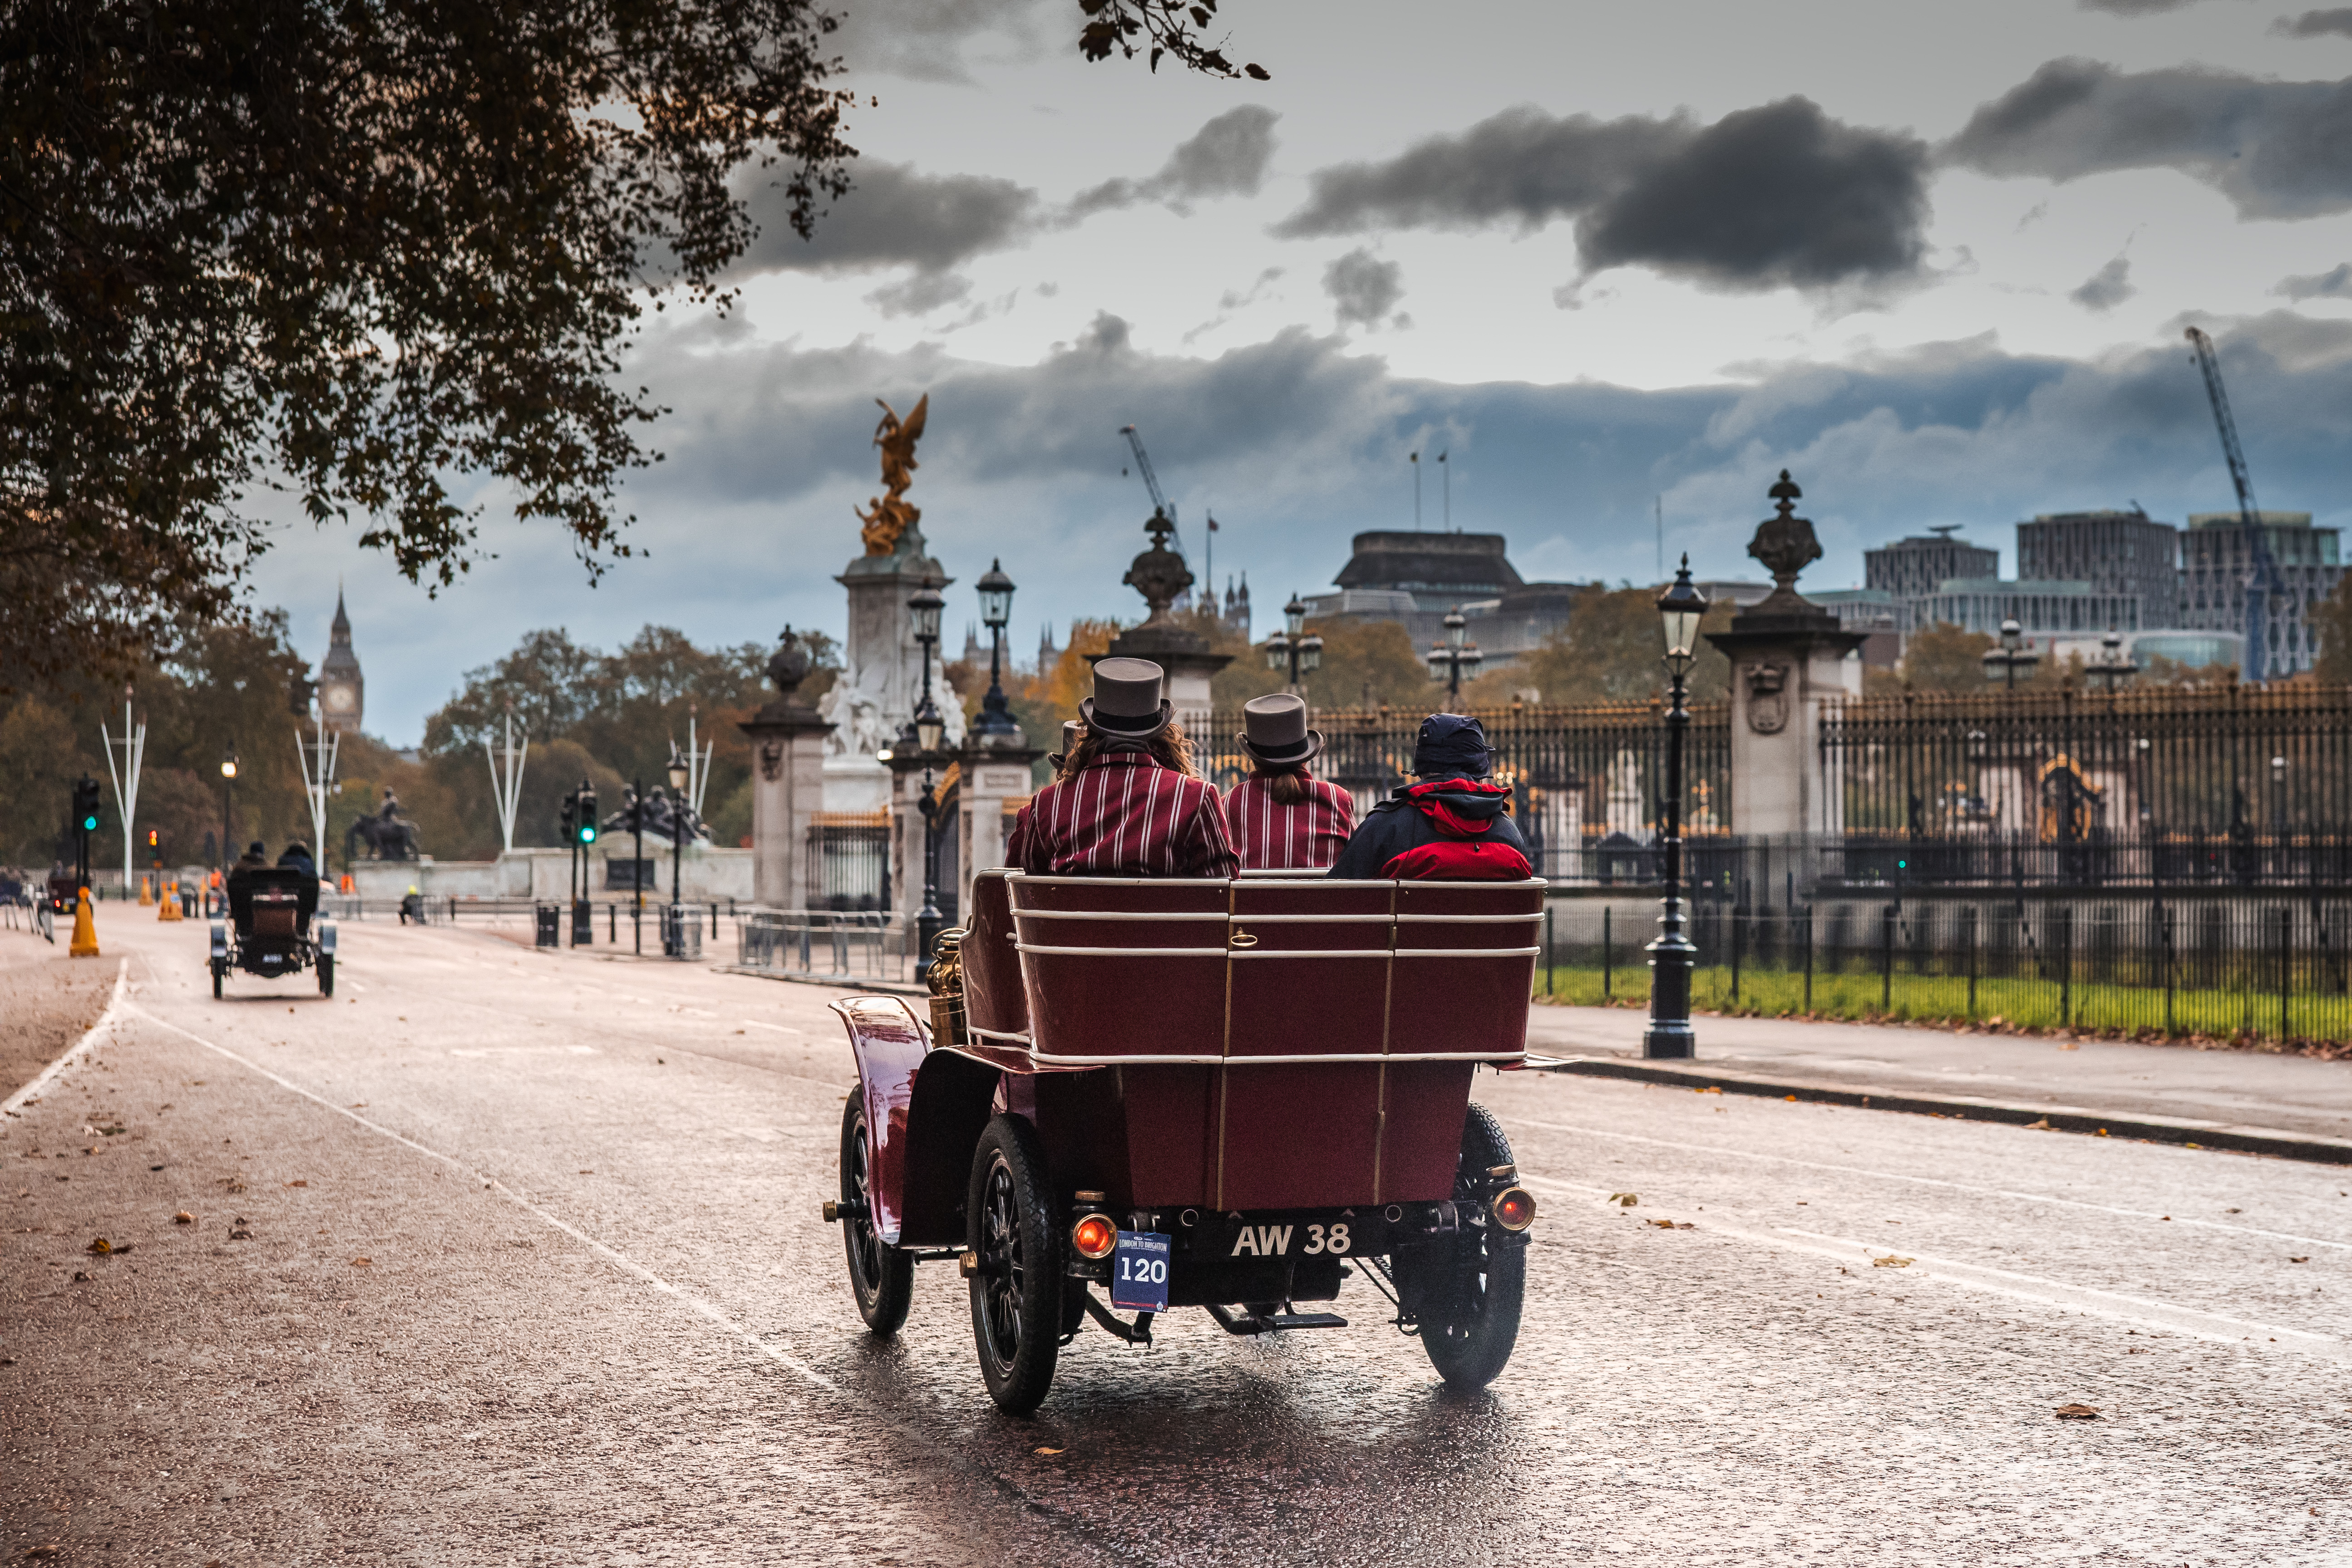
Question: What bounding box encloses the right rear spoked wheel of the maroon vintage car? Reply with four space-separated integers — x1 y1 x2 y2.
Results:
1397 1105 1526 1389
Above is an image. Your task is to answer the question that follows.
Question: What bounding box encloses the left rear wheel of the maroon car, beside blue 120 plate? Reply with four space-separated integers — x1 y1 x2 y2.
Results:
964 1117 1063 1415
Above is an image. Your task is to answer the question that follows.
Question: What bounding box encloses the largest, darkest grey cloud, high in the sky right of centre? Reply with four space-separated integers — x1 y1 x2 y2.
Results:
1275 99 1928 289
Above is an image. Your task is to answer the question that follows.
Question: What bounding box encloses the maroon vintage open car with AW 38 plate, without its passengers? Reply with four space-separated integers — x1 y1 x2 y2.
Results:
826 872 1543 1413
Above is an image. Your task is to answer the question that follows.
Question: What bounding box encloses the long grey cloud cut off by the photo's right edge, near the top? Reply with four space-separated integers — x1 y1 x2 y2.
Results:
1943 59 2352 219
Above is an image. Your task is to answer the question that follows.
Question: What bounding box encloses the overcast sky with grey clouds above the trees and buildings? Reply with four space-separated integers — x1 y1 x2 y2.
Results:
259 0 2352 743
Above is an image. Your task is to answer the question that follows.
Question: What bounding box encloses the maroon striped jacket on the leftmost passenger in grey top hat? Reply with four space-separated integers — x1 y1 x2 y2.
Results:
1018 752 1235 877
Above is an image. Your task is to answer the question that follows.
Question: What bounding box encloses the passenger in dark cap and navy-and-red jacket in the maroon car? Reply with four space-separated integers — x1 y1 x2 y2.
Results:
1331 712 1536 882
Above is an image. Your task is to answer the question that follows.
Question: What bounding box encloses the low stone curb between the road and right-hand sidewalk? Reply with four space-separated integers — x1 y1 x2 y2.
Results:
1526 1055 2352 1166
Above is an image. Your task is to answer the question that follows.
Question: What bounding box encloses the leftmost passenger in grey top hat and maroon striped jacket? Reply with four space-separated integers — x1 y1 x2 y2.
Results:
1018 658 1239 877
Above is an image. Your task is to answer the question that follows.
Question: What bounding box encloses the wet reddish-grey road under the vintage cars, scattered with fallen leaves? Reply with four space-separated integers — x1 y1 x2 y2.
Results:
0 914 2352 1566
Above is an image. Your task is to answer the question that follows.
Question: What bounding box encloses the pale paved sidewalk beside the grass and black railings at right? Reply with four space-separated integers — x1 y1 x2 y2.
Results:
1526 1006 2352 1164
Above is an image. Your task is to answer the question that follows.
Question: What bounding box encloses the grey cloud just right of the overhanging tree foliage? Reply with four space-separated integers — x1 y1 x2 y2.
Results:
736 160 1037 273
